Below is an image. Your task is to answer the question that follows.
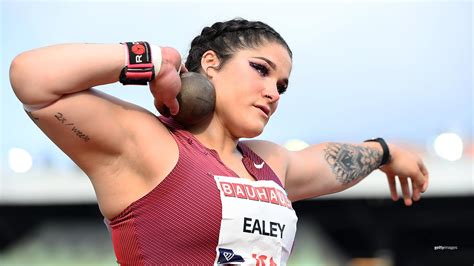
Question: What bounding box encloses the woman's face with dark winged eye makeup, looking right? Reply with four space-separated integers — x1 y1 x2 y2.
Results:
212 42 292 138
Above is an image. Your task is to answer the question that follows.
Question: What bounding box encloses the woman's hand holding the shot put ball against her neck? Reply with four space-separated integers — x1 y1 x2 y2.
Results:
149 47 188 116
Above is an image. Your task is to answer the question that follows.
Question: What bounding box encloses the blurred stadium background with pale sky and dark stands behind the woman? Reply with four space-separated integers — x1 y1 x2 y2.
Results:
0 0 474 265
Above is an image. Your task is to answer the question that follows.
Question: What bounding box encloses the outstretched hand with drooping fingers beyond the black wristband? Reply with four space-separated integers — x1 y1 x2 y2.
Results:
380 145 429 206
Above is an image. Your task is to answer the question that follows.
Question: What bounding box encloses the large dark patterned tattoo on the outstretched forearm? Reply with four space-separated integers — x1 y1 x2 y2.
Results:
324 143 382 184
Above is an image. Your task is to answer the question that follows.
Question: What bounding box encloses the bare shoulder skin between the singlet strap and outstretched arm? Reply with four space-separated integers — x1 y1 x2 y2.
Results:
242 140 290 184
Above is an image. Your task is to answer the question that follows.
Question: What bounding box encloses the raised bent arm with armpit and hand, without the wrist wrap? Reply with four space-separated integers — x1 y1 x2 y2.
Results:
10 44 187 218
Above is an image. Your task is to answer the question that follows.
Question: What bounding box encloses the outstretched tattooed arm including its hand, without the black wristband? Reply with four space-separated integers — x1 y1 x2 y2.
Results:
286 142 428 205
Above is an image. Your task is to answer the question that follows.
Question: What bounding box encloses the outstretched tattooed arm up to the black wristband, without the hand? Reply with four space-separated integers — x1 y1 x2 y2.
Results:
286 142 382 200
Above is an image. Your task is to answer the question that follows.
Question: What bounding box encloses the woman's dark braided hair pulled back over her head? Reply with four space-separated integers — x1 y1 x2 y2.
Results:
185 18 293 72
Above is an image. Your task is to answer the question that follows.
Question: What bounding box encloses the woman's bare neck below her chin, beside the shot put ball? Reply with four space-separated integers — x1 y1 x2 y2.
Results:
188 115 239 158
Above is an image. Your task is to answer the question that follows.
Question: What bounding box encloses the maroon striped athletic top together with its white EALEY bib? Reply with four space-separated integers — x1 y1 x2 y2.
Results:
106 116 297 265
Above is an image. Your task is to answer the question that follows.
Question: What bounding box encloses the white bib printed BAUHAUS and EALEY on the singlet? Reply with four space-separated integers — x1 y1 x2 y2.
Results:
214 176 298 266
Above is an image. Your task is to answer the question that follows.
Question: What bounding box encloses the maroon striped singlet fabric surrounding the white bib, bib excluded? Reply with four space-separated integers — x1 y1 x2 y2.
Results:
108 116 282 265
